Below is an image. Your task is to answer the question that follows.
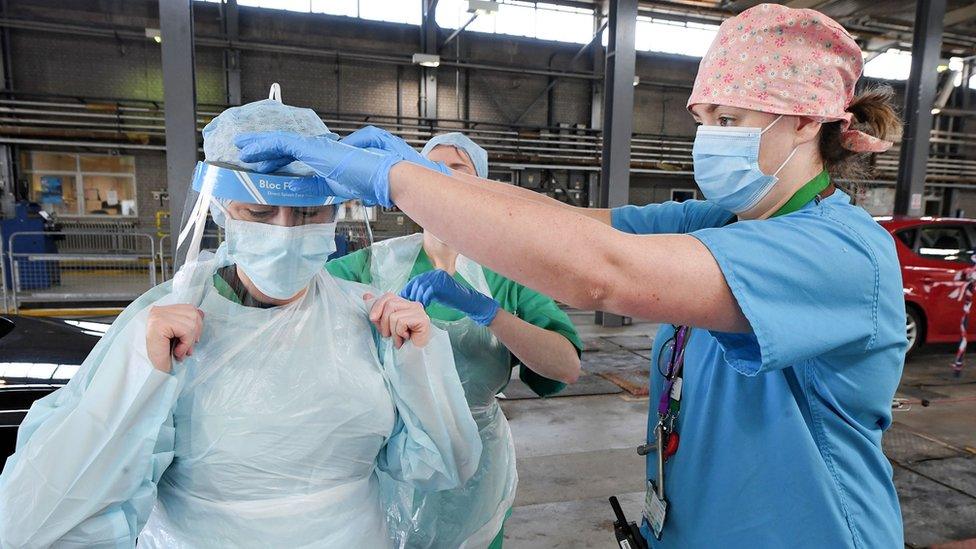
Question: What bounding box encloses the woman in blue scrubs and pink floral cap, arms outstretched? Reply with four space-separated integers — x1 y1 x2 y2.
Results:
239 4 907 548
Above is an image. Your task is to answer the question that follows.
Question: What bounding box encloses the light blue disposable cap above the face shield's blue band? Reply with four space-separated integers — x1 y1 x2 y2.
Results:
203 99 339 175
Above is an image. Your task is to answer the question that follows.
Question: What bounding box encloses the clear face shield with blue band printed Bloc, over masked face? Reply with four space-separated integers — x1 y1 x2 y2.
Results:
177 158 372 304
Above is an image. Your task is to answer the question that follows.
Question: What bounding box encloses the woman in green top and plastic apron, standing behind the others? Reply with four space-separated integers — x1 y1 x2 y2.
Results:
327 128 582 548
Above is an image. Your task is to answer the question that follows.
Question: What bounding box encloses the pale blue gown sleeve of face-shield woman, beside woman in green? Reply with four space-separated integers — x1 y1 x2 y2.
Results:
377 328 482 490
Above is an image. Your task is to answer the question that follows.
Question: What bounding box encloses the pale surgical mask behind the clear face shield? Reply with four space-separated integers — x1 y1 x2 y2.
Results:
226 216 336 299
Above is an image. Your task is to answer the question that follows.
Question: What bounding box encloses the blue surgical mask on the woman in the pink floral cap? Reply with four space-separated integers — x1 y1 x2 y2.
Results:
691 115 797 214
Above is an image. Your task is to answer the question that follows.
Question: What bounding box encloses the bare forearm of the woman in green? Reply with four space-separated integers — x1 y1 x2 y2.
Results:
488 310 580 383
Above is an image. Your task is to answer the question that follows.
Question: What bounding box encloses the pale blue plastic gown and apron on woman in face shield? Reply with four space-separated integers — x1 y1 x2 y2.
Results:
0 248 481 548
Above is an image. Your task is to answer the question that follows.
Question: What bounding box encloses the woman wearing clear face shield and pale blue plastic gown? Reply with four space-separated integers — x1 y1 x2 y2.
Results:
0 95 481 548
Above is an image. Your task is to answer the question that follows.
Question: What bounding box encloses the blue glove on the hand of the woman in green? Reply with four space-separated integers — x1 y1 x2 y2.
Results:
400 269 501 326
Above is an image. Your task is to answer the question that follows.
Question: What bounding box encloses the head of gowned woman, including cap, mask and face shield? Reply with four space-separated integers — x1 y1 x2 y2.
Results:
174 84 372 304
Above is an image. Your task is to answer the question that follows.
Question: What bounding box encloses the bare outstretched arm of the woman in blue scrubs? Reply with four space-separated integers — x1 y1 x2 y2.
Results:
389 162 749 332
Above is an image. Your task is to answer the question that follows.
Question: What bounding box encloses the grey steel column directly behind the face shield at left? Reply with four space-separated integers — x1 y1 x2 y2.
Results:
159 0 197 267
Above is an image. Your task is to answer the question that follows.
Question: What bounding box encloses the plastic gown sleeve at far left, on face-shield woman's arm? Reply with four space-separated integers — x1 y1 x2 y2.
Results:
0 286 178 549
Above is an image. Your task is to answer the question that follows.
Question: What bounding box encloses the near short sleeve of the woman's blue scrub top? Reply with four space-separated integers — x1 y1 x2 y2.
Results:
692 208 883 376
